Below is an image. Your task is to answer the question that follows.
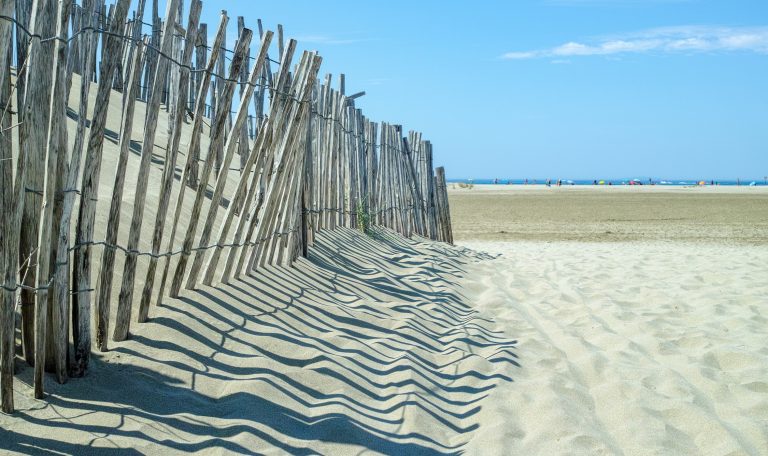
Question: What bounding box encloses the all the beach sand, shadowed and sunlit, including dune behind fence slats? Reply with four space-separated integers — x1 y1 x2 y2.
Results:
0 74 768 455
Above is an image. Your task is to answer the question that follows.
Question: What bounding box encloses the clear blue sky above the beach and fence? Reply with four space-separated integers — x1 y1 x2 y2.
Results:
142 0 768 179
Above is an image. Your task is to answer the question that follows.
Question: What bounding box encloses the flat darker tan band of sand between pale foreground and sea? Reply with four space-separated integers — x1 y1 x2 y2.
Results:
449 184 768 245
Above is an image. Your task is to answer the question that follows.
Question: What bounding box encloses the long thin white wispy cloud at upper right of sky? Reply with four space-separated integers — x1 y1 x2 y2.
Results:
501 26 768 60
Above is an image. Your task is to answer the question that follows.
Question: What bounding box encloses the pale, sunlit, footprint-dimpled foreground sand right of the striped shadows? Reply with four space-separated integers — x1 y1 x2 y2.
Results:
467 242 768 455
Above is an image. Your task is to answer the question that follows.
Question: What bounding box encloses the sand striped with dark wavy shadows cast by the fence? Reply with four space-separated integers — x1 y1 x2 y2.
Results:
0 229 519 454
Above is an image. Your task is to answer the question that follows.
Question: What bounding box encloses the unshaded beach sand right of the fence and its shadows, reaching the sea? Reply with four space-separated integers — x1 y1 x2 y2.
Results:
449 184 768 455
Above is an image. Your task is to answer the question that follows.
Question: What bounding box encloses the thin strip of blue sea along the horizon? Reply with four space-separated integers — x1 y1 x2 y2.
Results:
446 178 768 187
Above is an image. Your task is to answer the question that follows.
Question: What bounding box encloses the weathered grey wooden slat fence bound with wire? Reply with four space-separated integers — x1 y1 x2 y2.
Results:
0 0 452 412
